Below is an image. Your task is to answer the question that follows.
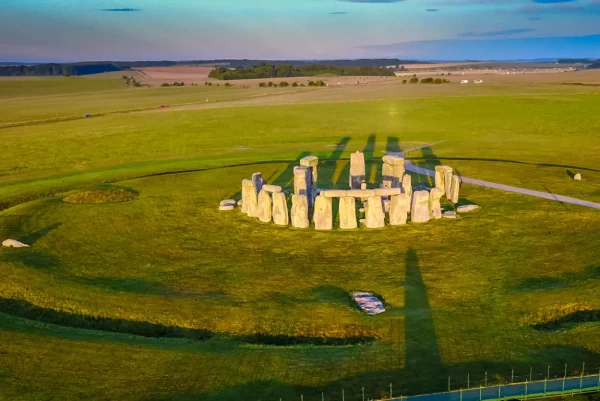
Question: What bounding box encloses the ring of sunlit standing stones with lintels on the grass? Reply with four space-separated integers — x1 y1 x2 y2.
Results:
219 152 477 231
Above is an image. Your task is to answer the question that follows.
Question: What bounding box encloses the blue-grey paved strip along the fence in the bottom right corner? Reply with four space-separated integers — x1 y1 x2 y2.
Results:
395 375 600 401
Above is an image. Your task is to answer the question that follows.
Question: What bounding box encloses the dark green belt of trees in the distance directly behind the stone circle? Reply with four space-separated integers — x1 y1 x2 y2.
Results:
208 63 395 80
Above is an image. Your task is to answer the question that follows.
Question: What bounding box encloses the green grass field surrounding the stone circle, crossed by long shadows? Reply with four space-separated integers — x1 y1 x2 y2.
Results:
0 75 600 401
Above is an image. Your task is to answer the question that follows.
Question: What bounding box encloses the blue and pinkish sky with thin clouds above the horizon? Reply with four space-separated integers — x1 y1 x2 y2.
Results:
0 0 600 62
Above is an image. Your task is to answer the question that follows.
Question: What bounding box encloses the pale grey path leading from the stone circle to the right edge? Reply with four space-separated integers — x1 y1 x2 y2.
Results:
390 141 600 209
